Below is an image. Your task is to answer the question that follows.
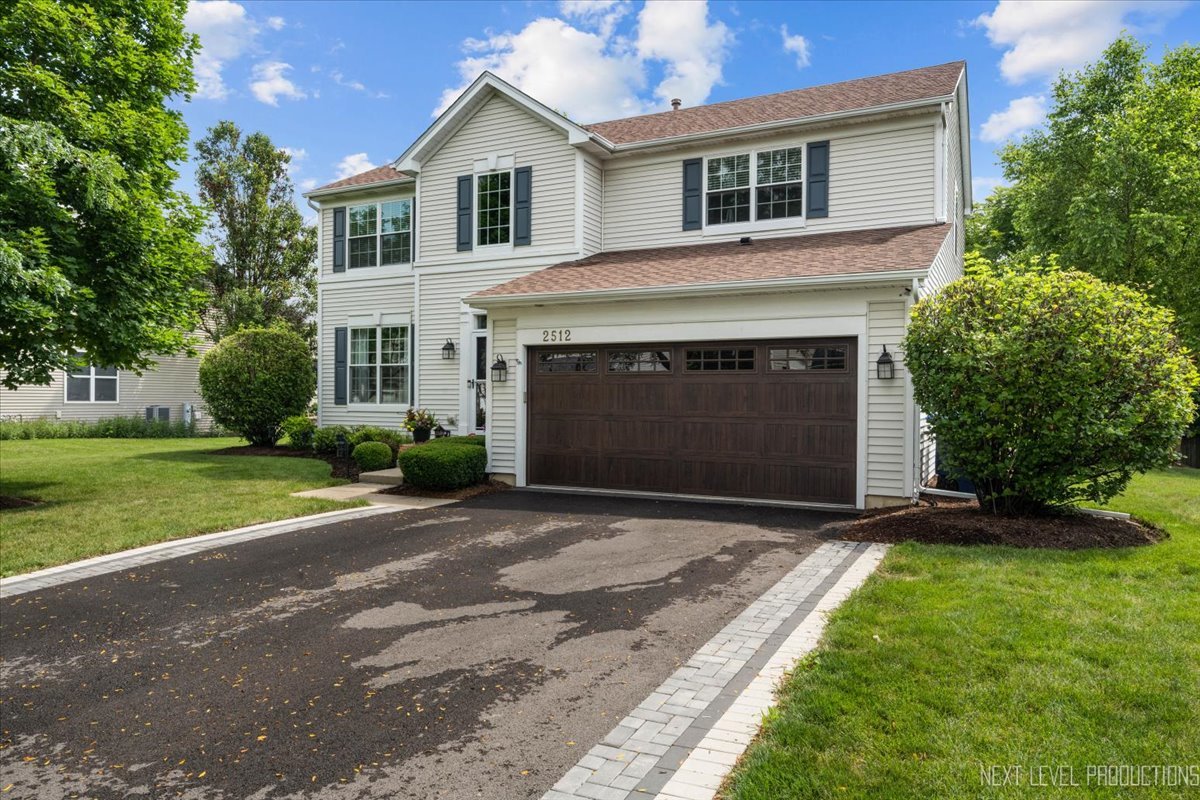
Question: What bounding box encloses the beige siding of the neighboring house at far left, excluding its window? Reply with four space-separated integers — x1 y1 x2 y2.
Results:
0 339 212 427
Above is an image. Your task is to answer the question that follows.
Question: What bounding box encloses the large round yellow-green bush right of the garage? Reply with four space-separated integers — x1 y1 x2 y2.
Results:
904 272 1198 513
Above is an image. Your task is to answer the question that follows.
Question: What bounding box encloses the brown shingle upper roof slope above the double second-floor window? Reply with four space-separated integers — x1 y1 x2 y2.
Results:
583 61 966 144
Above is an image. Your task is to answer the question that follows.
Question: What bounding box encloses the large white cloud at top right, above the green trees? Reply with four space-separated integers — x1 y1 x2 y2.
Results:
974 0 1187 84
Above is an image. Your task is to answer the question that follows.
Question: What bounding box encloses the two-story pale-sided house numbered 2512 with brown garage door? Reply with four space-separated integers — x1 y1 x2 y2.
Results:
307 62 971 507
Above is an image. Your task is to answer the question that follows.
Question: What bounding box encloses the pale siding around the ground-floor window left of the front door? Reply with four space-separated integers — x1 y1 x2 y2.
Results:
317 276 420 429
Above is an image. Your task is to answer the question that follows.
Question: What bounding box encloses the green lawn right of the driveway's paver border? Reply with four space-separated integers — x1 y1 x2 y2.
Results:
724 469 1200 800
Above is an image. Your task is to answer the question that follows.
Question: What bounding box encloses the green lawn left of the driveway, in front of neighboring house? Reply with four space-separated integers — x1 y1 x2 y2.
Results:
0 439 356 576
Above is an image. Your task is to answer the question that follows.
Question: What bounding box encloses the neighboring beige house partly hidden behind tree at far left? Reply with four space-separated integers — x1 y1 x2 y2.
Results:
0 339 212 428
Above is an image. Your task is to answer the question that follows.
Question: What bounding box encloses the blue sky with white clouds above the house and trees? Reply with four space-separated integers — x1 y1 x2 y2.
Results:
179 0 1200 209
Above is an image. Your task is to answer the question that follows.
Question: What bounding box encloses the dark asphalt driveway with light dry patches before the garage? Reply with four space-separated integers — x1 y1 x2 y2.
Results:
0 492 847 799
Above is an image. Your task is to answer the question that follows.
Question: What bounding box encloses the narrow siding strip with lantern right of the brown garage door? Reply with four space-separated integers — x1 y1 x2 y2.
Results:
866 300 910 498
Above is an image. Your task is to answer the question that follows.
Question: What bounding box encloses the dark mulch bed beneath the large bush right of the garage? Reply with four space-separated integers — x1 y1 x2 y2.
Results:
841 500 1166 551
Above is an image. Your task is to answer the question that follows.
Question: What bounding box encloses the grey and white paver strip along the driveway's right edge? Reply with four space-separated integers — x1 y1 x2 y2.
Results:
542 542 887 800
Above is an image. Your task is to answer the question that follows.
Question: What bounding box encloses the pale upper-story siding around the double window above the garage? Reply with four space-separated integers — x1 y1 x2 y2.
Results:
604 118 935 251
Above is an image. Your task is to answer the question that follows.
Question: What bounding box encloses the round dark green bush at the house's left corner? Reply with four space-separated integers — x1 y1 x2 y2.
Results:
200 327 317 446
